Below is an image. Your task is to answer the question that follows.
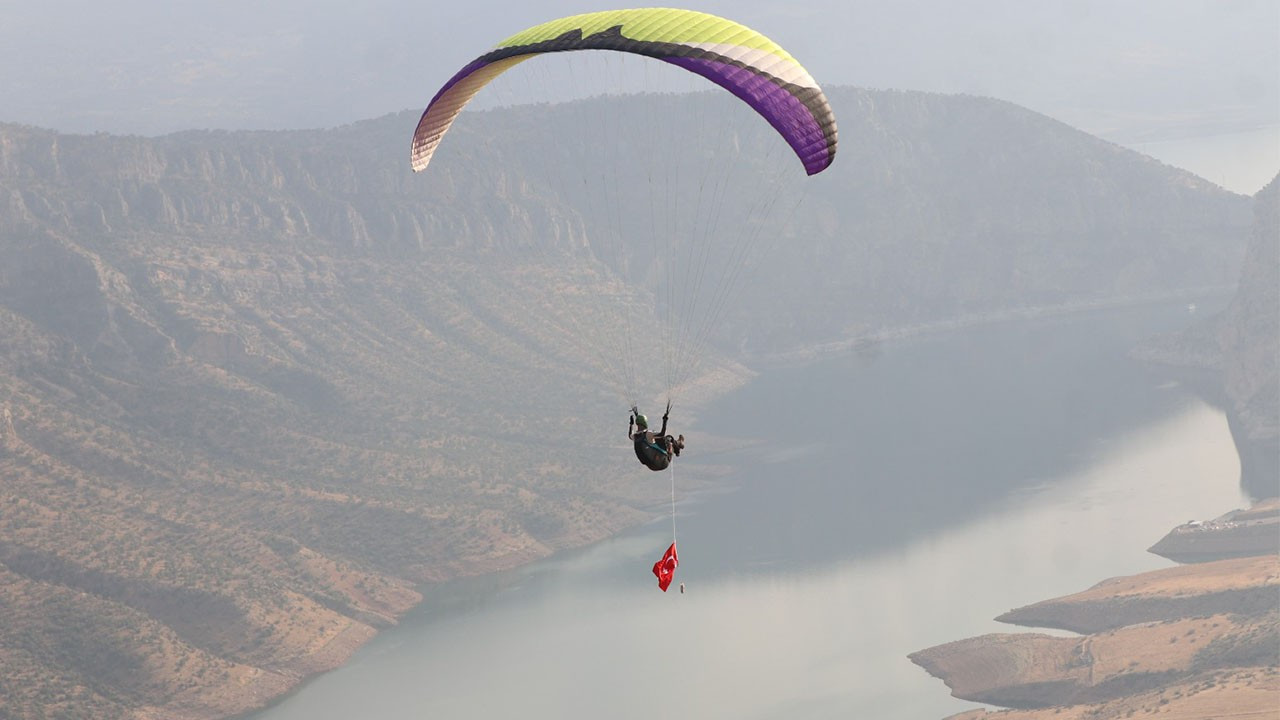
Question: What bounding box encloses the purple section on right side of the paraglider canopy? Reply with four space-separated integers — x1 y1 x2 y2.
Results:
660 58 831 176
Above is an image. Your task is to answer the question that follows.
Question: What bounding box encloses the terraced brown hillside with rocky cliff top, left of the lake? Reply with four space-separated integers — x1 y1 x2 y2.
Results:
0 122 691 717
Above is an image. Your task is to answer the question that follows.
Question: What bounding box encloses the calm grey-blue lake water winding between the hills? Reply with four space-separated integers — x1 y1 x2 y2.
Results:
255 297 1247 720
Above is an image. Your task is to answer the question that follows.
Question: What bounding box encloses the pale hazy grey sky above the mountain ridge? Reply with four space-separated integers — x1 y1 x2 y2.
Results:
0 0 1280 191
